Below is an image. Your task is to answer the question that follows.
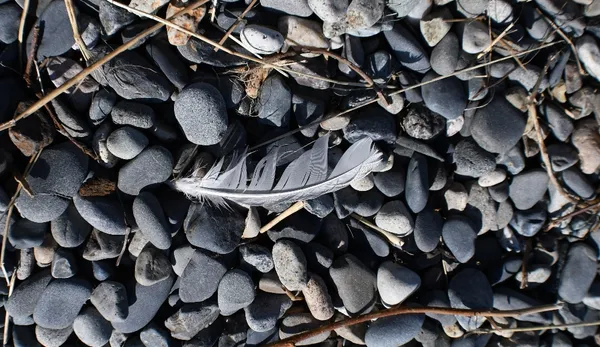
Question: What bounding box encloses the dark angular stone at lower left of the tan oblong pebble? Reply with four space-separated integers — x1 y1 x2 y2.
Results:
244 292 292 332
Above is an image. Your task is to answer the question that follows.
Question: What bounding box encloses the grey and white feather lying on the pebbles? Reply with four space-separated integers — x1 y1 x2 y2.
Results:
174 136 383 206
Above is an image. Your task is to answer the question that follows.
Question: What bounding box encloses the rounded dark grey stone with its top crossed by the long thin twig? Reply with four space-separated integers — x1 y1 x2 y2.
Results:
421 71 467 120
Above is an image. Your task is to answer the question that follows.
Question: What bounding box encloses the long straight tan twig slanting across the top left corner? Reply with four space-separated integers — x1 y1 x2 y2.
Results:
0 0 208 131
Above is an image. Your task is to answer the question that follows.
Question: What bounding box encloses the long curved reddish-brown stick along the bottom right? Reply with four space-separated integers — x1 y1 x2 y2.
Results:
267 305 561 347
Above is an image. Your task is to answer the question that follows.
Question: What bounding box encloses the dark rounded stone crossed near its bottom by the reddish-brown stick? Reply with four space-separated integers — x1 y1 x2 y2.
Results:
448 269 494 331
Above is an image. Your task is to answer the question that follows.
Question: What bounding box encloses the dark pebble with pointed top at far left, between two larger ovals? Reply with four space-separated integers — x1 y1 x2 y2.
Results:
50 204 92 248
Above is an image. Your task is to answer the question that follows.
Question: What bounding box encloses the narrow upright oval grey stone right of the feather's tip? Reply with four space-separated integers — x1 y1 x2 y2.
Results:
404 154 429 213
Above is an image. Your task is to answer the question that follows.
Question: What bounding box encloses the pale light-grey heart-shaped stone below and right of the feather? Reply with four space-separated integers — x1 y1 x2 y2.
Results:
377 261 421 306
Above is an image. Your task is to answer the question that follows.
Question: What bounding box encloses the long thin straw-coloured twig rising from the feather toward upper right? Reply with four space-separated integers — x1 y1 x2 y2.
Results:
249 41 564 151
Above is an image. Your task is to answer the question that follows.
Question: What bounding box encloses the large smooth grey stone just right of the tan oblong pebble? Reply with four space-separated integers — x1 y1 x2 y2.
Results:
329 254 377 314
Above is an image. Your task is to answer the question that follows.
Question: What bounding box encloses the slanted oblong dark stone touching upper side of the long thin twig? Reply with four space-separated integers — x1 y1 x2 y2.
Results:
383 23 431 73
